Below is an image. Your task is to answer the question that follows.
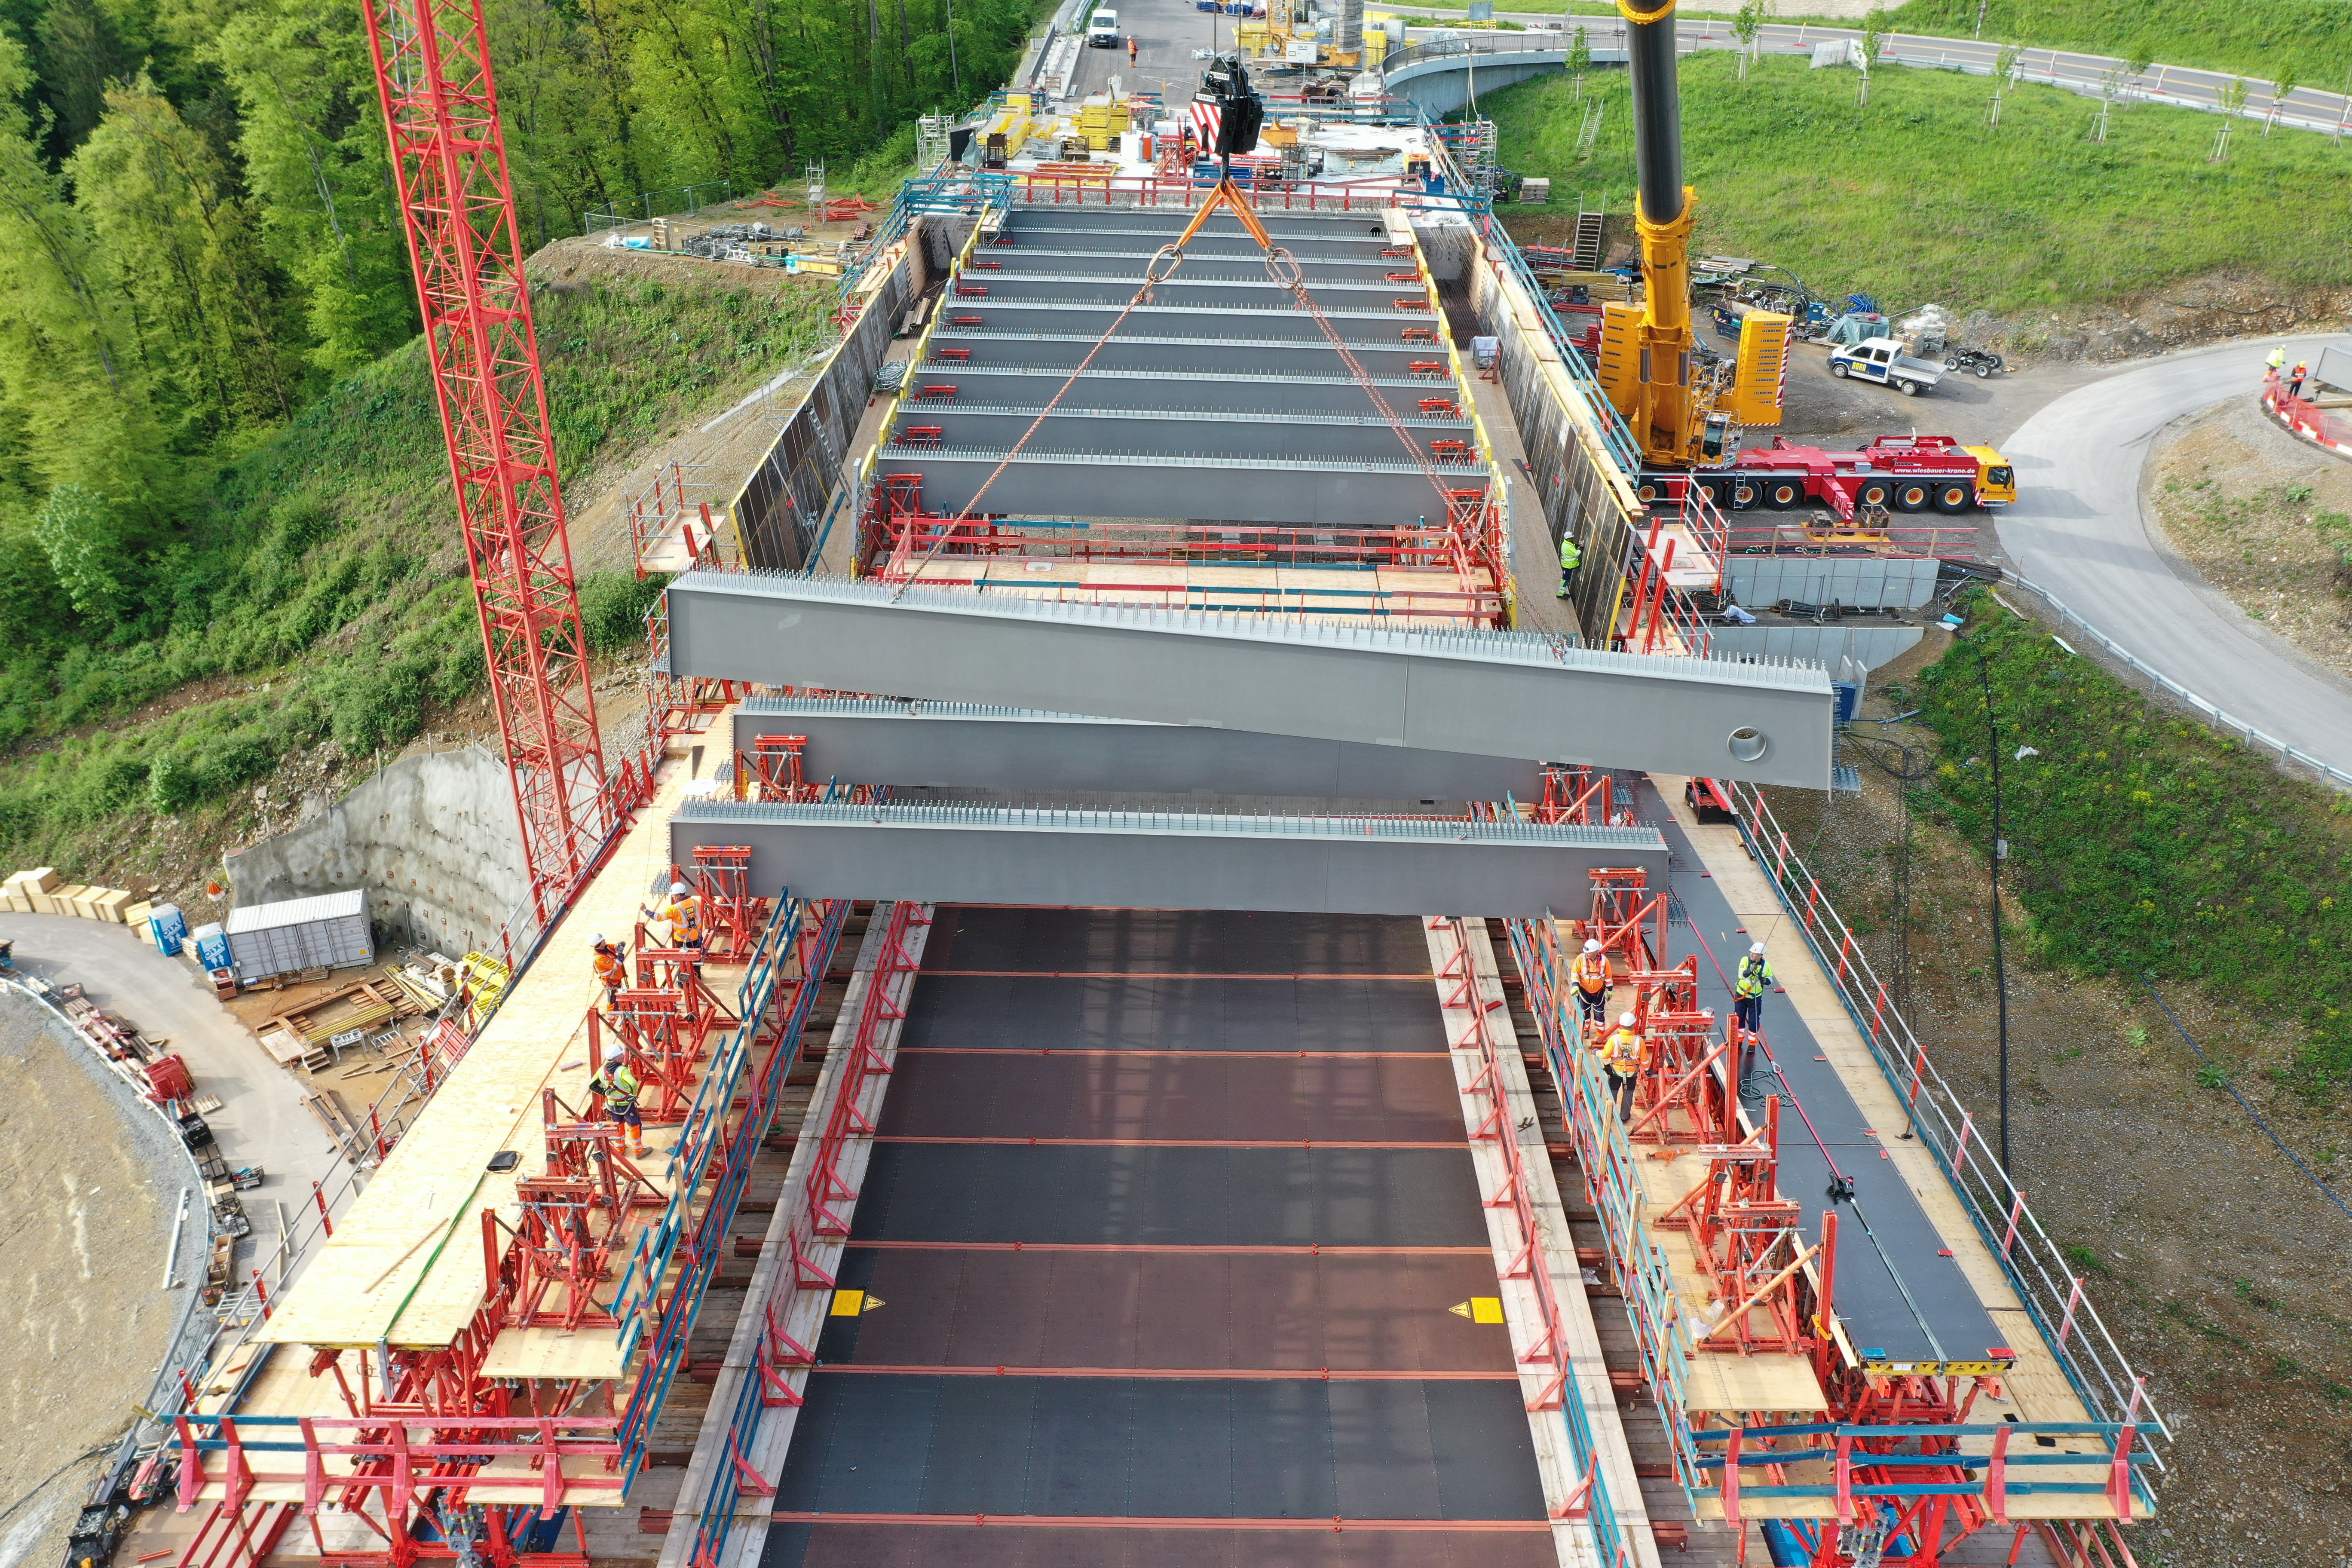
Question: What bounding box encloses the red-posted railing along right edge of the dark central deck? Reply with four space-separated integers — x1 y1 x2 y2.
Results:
1430 917 1630 1568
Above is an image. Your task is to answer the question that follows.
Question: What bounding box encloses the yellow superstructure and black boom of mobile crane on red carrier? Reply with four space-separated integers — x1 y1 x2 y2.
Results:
1597 0 1792 468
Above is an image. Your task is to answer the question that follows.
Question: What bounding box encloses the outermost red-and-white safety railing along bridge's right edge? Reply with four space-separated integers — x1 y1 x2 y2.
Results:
1724 783 2171 1467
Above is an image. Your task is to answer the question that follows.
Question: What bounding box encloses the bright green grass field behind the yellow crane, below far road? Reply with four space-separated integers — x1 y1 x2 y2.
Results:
1482 54 2352 312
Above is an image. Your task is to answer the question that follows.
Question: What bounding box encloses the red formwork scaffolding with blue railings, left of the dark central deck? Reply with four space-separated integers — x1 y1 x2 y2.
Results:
176 896 849 1568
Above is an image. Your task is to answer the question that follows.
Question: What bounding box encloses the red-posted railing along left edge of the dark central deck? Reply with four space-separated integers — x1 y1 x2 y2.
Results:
687 900 931 1568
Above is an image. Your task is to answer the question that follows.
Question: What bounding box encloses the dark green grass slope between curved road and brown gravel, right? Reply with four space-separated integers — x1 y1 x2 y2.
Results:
1912 592 2352 1093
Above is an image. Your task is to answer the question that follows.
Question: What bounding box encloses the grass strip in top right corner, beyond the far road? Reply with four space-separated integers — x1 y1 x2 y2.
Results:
1889 0 2352 92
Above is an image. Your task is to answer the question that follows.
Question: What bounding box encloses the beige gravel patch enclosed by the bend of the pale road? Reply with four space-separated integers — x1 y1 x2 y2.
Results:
2147 397 2352 675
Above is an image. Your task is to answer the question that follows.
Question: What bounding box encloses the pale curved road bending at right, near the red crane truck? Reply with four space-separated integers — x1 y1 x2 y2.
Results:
1999 336 2352 790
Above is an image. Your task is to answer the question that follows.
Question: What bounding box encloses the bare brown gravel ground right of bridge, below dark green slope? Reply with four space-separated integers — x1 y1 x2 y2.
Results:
1773 632 2352 1568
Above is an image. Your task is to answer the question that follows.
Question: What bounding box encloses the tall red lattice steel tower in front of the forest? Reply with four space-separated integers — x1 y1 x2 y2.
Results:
364 0 604 919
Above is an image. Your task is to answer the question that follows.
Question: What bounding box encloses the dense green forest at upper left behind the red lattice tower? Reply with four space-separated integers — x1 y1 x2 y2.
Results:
0 0 1032 663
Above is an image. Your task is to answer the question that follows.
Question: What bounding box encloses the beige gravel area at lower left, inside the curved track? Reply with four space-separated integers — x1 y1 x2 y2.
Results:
0 997 205 1568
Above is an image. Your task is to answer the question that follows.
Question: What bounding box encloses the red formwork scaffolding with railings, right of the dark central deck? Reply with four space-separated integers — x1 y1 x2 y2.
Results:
1508 851 2162 1568
